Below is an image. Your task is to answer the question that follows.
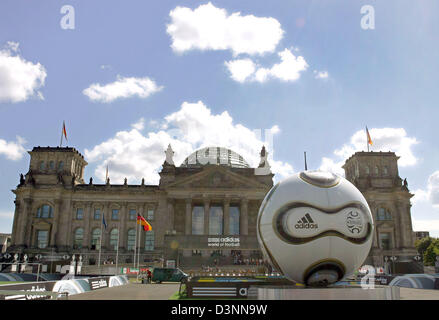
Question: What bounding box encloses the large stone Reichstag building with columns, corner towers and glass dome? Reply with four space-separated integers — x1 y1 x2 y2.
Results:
8 146 416 268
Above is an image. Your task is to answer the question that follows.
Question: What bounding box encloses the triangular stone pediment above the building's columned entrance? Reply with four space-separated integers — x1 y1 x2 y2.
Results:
166 165 268 189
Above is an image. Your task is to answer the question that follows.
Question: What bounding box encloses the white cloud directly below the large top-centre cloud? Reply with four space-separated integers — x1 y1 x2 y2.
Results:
225 49 308 82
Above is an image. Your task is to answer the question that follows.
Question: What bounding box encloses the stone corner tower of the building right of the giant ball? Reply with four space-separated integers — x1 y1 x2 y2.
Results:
343 152 417 272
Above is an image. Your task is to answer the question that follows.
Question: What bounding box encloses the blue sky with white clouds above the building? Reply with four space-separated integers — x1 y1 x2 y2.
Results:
0 0 439 236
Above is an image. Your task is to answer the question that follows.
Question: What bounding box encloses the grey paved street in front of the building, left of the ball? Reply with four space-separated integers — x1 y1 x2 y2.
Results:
69 283 180 300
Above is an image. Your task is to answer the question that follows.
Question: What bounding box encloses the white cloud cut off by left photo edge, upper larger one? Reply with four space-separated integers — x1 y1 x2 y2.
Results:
0 41 47 103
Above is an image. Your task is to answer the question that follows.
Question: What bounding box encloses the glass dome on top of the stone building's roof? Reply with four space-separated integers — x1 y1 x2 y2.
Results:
180 147 250 168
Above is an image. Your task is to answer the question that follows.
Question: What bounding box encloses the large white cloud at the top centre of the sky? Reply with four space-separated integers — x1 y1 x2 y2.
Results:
167 2 284 55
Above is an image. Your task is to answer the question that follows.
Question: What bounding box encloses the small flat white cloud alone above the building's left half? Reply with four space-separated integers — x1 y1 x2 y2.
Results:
82 76 163 103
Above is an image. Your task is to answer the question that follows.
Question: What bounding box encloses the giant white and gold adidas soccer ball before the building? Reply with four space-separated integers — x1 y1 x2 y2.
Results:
257 171 373 286
